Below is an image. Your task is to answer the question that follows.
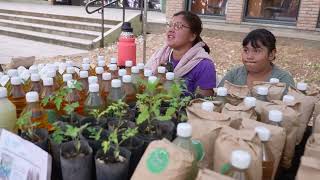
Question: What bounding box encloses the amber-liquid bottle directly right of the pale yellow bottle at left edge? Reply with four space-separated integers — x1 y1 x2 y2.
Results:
9 77 26 117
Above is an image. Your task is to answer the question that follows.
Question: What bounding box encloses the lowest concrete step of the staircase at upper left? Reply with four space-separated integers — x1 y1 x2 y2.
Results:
0 26 93 50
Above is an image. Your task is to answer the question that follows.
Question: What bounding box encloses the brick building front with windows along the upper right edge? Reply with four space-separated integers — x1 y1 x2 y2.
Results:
166 0 320 31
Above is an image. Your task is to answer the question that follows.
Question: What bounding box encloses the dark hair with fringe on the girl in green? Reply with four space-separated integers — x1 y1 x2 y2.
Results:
242 29 276 53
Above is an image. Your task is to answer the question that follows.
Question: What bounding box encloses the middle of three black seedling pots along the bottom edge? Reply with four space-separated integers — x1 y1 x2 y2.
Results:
95 147 131 180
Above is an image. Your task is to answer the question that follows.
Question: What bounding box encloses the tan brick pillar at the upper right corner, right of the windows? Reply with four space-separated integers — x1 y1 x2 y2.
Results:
297 0 320 30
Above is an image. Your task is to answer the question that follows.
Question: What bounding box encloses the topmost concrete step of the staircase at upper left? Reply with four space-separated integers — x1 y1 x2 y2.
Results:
0 7 120 25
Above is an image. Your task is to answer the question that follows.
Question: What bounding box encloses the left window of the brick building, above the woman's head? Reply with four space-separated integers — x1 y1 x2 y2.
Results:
190 0 228 16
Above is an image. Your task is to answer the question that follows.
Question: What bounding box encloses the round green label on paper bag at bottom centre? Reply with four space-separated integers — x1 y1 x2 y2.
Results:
147 148 169 174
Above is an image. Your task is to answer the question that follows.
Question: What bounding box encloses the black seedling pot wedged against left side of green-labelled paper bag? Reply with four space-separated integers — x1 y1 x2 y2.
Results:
121 137 144 178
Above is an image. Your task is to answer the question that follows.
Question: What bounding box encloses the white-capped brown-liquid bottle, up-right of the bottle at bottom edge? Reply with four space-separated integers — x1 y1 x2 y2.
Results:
255 126 274 180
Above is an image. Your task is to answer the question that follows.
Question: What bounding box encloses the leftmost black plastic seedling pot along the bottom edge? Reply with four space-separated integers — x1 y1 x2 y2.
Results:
60 140 93 180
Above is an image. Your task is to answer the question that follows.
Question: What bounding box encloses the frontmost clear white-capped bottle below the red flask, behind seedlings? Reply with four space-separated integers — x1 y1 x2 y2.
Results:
107 79 125 105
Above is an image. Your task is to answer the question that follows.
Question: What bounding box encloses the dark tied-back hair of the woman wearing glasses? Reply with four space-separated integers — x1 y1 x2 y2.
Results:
173 11 210 54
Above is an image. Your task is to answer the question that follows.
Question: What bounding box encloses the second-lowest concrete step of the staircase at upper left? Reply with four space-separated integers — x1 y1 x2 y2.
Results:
0 19 100 40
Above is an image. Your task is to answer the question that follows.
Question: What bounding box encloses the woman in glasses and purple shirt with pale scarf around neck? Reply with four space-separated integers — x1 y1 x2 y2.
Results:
146 11 216 96
